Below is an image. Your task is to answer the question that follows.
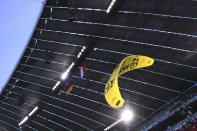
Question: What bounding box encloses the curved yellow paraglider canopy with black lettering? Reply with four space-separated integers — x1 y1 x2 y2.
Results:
104 55 154 108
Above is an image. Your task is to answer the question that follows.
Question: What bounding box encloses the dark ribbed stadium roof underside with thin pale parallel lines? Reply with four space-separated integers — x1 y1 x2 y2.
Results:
0 0 197 131
